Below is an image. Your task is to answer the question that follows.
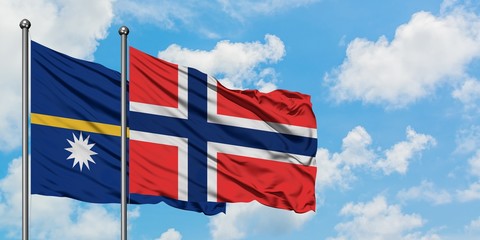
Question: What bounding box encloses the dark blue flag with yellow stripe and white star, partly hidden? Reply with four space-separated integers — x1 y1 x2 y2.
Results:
31 41 225 215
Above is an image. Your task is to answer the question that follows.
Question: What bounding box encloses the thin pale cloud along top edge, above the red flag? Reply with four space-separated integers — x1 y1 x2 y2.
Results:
218 0 318 21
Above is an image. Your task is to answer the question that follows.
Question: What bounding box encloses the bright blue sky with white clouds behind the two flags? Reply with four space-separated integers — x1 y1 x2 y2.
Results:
0 0 480 240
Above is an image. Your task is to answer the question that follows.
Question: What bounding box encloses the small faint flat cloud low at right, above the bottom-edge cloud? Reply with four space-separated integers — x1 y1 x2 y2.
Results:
397 181 452 205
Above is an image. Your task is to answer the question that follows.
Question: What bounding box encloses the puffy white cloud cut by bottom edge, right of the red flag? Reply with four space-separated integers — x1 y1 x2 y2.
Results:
330 196 438 240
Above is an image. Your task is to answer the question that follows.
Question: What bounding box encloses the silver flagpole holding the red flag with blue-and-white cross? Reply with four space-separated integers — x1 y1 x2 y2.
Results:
118 26 129 240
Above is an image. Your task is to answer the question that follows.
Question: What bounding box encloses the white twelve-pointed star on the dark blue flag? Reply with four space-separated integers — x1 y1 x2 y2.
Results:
65 132 97 171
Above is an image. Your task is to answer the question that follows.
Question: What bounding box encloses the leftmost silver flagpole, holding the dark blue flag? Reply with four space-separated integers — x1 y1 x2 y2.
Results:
20 19 31 240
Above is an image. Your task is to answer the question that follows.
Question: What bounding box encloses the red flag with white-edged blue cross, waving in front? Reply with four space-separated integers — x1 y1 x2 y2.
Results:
129 47 317 213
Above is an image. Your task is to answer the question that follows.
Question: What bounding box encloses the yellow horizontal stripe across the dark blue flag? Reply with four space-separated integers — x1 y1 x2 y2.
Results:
30 113 130 137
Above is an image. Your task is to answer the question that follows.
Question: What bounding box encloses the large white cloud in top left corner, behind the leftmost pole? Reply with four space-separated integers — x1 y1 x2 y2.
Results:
0 0 113 150
